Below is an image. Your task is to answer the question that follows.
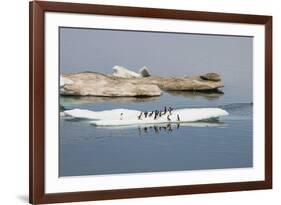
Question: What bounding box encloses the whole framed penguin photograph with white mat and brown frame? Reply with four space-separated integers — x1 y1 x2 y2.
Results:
30 1 272 204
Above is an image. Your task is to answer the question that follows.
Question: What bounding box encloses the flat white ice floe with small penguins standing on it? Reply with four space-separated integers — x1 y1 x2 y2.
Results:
64 108 228 126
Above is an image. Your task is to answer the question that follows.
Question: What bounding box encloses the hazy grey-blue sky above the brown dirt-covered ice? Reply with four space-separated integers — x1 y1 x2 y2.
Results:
59 27 253 100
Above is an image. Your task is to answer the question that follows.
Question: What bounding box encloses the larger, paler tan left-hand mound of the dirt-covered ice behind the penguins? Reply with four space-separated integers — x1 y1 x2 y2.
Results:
60 72 162 97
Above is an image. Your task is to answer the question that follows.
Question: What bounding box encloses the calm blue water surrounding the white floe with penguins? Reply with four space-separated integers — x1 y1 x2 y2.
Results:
59 89 253 176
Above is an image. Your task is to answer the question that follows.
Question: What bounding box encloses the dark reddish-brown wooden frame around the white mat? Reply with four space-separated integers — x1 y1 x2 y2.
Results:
29 1 272 204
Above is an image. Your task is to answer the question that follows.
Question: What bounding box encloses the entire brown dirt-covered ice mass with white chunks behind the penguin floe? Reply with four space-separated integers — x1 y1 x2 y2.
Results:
60 66 223 97
